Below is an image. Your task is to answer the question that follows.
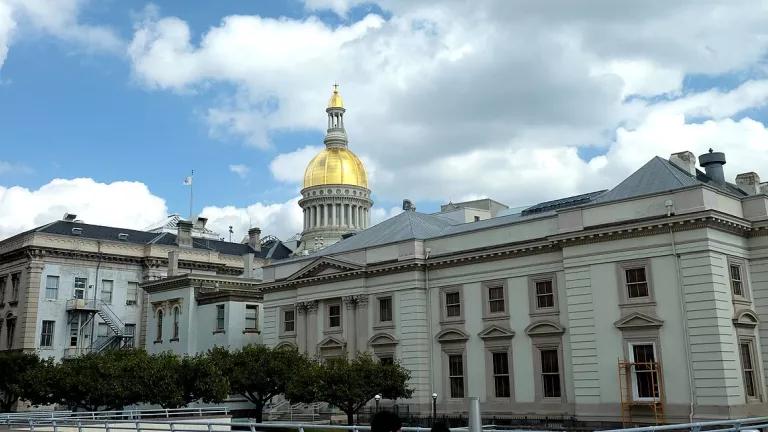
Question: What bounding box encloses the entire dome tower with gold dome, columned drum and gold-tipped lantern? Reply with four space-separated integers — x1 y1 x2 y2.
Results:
299 86 373 251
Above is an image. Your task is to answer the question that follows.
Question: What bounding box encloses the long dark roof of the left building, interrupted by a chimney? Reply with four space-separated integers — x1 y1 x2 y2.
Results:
28 220 276 258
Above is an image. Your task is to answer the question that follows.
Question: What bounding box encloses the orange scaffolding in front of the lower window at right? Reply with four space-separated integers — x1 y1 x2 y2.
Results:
618 360 664 427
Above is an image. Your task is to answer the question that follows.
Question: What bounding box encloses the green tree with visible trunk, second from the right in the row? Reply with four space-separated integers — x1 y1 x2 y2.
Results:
209 345 311 422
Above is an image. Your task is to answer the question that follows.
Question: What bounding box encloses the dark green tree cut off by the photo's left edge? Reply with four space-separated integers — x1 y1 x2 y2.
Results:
0 351 47 412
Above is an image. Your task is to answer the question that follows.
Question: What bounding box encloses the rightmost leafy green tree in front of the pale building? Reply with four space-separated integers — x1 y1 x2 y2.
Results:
288 353 413 425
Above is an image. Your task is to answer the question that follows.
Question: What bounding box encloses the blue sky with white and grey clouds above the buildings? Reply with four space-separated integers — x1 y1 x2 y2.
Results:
0 0 768 238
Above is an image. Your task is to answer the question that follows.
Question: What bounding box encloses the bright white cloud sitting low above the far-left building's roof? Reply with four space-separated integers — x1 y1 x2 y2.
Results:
0 178 168 238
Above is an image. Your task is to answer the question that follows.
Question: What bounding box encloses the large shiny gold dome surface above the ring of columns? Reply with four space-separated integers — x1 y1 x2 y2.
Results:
304 147 368 188
